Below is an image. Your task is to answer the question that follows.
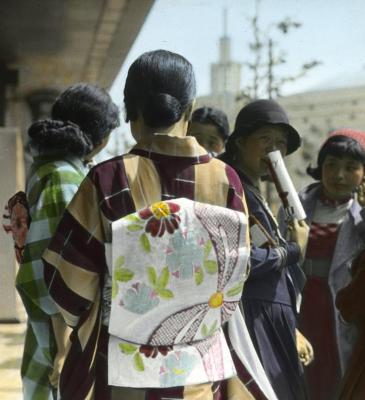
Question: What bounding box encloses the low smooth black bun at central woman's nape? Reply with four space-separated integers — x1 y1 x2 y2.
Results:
142 93 183 128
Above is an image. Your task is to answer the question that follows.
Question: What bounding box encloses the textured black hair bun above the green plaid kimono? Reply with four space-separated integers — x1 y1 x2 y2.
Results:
28 119 93 156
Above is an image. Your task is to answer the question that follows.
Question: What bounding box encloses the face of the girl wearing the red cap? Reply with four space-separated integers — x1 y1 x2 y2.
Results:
322 155 364 199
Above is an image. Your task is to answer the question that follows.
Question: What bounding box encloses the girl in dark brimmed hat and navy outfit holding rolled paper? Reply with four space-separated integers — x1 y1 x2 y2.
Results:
221 100 308 400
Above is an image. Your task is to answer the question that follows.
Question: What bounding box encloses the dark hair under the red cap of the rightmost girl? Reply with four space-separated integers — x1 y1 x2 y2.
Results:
307 135 365 181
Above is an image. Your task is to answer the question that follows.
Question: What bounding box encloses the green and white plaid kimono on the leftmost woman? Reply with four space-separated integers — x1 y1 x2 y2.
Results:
16 156 87 400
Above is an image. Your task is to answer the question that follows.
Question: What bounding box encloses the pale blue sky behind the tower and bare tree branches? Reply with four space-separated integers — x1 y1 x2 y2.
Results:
98 0 365 159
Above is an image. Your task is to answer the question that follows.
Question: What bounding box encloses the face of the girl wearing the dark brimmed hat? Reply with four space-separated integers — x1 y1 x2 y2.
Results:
236 125 288 178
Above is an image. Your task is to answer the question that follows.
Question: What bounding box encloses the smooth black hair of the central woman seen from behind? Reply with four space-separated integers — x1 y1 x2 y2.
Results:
124 50 196 128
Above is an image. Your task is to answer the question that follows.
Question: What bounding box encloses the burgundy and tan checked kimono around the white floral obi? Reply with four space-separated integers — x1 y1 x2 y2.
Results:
43 134 250 400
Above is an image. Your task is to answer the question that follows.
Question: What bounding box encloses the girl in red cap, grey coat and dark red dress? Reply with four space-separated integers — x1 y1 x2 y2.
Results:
299 129 365 400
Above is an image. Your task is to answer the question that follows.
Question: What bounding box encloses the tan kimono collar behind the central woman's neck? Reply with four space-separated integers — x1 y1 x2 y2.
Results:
132 133 211 160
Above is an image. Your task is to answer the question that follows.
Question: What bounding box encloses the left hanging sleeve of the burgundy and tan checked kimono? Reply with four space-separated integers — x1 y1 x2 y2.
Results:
43 174 107 326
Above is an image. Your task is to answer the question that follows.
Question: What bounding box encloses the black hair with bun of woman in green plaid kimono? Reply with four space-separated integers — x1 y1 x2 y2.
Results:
28 83 119 157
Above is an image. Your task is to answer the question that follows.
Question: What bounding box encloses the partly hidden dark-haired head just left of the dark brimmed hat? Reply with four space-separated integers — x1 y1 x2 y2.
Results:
188 107 229 156
